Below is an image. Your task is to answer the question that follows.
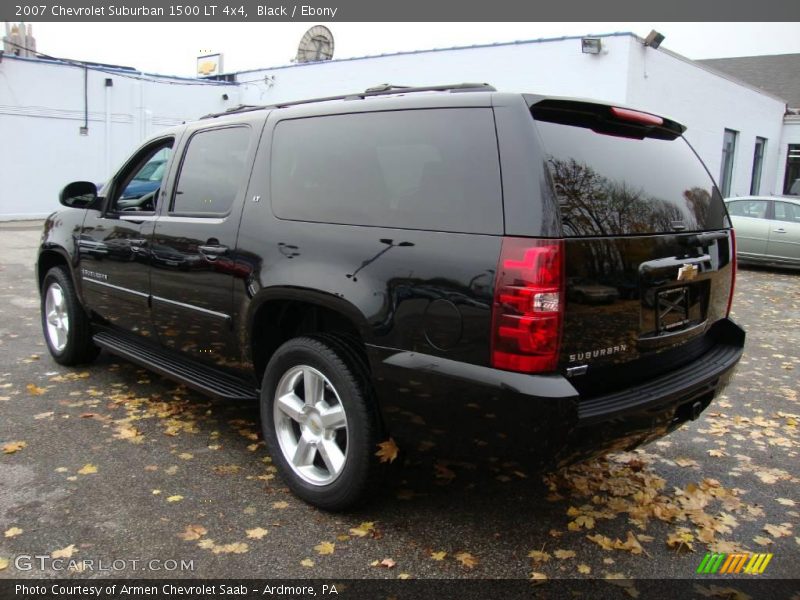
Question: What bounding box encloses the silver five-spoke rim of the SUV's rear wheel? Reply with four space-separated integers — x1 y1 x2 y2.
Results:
273 365 348 486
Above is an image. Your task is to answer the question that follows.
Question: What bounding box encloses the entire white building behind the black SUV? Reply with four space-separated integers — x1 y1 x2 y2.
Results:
0 33 788 219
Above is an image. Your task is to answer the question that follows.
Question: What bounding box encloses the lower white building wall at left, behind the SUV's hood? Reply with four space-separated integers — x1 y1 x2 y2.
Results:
0 56 239 220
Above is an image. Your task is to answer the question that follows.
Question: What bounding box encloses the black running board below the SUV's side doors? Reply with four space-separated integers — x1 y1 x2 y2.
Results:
92 331 258 400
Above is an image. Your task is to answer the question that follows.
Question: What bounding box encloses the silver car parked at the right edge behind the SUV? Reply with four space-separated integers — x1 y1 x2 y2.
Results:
725 196 800 267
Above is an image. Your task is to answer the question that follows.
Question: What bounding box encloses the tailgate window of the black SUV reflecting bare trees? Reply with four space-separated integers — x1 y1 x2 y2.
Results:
534 107 727 237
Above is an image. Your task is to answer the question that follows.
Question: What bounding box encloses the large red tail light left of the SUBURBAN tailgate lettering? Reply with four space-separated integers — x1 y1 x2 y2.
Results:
492 237 565 373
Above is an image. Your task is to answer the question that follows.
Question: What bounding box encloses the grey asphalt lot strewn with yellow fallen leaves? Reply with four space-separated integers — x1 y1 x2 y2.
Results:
0 218 800 595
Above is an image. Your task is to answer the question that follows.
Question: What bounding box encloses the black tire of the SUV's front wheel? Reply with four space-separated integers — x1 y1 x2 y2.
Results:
41 267 100 366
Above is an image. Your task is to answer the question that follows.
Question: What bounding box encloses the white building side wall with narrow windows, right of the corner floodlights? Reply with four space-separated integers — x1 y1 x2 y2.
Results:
627 38 786 196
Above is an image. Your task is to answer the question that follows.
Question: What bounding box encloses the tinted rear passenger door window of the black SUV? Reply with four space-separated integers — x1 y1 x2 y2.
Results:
172 127 250 215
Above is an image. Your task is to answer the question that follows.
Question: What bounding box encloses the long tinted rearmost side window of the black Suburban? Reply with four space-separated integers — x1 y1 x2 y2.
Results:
271 108 503 233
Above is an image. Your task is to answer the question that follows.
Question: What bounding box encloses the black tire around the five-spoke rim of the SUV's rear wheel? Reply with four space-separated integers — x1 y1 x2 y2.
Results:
261 336 381 511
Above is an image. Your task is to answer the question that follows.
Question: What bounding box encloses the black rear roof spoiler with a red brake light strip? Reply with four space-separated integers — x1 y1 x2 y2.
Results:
527 96 686 140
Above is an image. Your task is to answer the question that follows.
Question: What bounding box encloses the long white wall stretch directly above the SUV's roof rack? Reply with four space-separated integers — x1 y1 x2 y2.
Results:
237 35 629 104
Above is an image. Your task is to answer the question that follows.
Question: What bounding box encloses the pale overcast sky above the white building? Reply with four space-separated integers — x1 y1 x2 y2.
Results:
21 22 800 76
